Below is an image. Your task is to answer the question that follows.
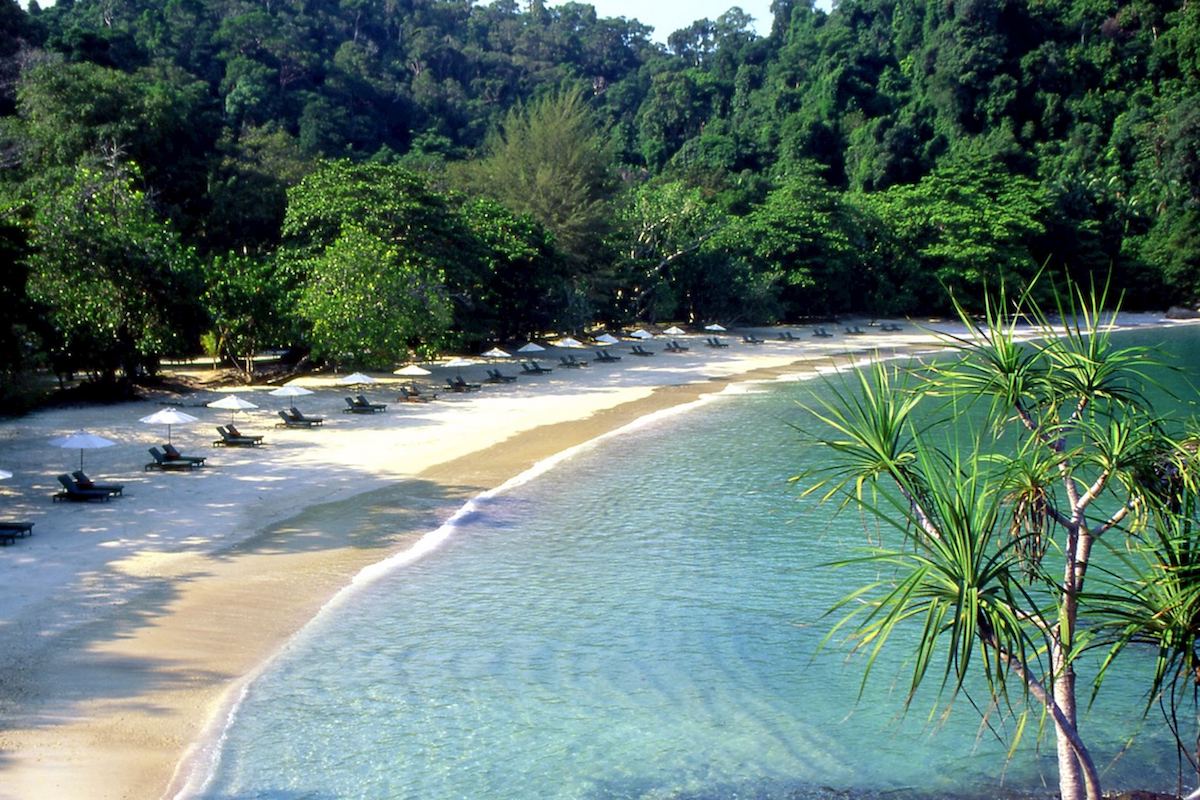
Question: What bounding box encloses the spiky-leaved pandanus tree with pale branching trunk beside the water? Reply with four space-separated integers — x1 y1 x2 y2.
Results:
797 280 1200 800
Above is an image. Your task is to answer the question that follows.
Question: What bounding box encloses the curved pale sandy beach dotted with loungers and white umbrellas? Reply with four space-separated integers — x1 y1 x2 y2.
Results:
0 315 1180 800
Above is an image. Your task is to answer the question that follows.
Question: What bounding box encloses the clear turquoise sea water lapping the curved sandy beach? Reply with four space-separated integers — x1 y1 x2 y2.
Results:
192 333 1196 800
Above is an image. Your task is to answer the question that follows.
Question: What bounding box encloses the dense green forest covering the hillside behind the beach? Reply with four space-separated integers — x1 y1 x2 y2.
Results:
0 0 1200 383
